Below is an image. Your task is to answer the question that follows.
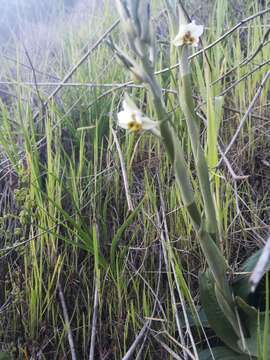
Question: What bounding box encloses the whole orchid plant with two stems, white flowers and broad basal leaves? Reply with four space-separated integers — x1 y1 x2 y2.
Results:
111 0 270 360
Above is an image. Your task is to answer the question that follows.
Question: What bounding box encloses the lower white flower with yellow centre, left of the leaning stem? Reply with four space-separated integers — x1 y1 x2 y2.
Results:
117 95 158 132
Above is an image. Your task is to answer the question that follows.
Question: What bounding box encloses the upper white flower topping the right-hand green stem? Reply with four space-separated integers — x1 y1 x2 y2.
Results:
173 20 203 46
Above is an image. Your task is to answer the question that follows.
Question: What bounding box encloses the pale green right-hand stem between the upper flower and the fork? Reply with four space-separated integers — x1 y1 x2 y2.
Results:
179 45 218 239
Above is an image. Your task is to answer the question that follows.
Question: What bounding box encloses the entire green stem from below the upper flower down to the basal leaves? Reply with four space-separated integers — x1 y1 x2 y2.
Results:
179 46 240 335
